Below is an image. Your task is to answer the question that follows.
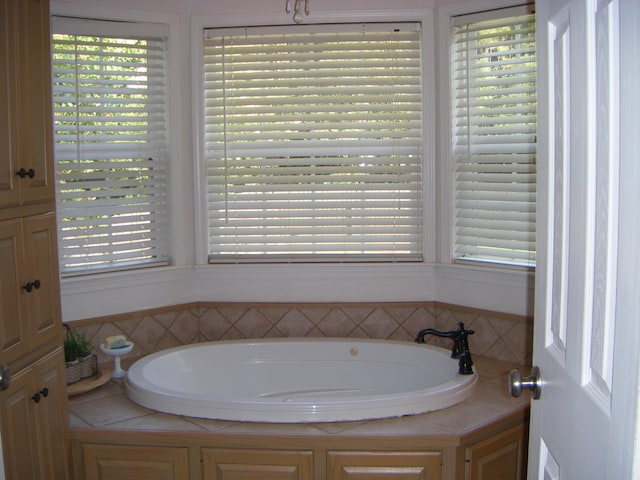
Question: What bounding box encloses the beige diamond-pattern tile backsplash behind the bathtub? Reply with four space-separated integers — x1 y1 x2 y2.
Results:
71 302 533 364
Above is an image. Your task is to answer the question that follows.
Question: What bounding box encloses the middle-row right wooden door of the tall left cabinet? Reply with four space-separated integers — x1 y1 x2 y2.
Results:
22 213 62 348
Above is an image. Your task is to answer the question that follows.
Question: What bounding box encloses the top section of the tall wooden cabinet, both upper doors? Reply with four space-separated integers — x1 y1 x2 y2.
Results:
0 0 54 208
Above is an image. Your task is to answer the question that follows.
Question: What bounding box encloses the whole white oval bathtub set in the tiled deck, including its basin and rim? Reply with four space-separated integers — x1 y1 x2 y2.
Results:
125 339 477 423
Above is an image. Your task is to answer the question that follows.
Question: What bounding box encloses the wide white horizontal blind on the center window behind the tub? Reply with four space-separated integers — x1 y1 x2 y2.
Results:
204 25 422 262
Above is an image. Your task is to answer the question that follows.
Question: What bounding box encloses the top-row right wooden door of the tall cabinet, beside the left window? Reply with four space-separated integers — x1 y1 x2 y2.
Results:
13 0 55 204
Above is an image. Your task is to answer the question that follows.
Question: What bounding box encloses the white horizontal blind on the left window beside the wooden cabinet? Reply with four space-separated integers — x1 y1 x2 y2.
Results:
52 19 170 275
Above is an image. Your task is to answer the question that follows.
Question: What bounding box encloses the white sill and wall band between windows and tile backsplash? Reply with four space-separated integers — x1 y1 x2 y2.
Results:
61 263 534 322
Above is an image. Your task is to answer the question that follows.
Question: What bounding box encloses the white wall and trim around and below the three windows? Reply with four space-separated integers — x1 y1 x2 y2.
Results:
51 0 533 321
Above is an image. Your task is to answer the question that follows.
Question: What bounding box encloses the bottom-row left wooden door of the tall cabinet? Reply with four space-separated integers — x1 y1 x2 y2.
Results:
0 358 42 480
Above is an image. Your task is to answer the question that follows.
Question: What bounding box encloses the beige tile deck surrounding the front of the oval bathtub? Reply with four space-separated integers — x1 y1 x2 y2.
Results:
69 357 530 438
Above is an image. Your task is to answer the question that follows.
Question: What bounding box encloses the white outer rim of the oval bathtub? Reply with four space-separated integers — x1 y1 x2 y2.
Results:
124 337 479 423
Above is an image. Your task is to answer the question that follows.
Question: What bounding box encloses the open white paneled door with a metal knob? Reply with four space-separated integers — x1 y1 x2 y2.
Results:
523 0 640 480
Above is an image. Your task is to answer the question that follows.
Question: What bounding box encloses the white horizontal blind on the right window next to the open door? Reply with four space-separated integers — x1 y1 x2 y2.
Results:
451 13 536 266
